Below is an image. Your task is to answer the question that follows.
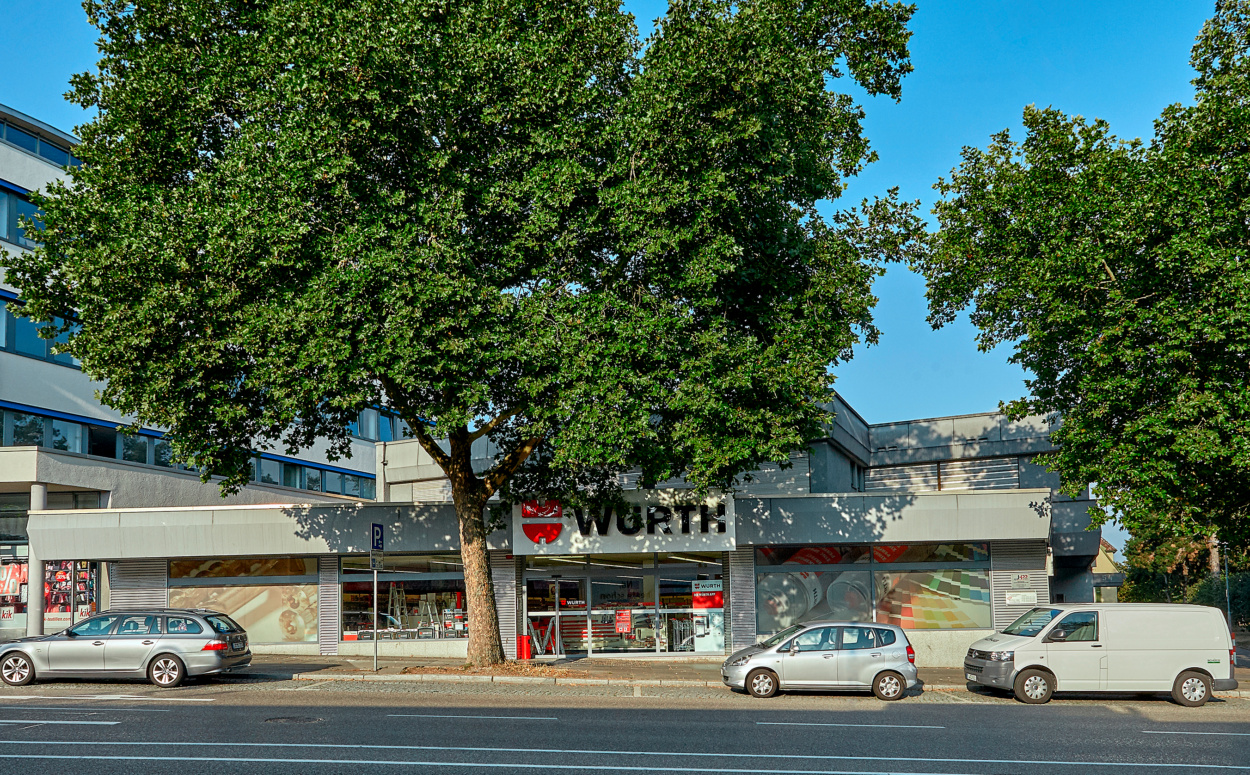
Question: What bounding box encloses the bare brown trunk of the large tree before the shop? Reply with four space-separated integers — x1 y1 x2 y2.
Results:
451 485 504 668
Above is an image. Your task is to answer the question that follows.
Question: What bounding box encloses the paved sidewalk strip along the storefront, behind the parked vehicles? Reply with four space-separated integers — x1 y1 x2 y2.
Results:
233 655 1250 699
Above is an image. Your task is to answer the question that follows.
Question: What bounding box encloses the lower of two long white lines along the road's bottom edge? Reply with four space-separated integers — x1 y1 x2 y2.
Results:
0 744 974 775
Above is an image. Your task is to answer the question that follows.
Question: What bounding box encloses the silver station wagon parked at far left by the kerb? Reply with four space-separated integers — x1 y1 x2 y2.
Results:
0 609 251 688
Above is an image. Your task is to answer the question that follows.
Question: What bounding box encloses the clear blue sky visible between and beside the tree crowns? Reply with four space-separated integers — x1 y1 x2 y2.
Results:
0 0 1214 540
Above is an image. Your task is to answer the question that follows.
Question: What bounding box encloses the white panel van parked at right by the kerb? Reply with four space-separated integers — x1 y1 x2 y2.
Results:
964 603 1238 706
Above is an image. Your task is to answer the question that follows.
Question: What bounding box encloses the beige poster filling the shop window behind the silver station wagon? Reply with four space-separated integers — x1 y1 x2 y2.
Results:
169 584 318 644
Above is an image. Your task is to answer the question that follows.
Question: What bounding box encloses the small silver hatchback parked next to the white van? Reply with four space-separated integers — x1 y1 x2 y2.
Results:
720 621 919 700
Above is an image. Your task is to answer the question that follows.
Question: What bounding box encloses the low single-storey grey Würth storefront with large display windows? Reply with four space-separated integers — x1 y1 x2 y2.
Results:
29 472 1065 665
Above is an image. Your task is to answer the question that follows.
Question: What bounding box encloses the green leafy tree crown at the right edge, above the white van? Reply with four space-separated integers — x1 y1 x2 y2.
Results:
918 0 1250 555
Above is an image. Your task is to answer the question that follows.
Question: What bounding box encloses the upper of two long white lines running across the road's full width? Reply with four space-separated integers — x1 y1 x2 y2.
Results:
0 740 1250 775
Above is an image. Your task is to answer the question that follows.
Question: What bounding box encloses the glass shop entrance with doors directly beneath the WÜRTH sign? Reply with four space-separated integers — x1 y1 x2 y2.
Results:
523 553 725 656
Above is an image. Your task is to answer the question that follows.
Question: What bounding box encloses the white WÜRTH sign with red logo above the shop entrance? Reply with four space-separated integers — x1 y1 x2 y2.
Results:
513 490 735 555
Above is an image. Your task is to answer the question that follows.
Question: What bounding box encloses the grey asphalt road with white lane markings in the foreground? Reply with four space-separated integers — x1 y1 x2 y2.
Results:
0 680 1250 775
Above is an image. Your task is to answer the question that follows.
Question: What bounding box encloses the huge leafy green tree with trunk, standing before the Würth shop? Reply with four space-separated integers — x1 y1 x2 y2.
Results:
10 0 916 664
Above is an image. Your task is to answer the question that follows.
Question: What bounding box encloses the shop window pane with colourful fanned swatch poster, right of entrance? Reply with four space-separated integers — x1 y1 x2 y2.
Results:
873 570 990 630
